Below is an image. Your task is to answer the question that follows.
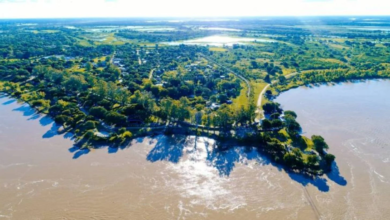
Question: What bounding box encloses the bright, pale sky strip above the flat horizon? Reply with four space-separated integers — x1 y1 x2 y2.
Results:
0 0 390 18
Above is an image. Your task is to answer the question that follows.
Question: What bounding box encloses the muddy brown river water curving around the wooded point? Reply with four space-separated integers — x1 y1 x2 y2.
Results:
0 81 390 219
